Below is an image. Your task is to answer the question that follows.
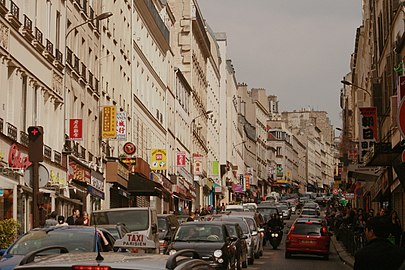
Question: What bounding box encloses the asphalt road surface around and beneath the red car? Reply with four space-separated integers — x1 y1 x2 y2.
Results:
247 215 352 270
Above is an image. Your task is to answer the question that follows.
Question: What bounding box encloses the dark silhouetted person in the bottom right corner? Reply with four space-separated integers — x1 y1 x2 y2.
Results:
354 217 405 270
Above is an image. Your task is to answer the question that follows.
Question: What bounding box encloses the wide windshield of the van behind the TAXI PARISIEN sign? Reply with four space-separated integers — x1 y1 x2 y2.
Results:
92 209 149 232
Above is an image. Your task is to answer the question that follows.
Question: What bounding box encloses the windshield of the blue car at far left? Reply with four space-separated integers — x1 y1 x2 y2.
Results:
8 230 95 255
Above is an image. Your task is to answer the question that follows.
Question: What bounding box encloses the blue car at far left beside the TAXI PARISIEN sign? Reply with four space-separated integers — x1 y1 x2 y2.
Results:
0 226 115 270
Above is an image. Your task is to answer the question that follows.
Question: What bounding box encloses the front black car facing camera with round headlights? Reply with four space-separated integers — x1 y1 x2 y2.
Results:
168 221 237 269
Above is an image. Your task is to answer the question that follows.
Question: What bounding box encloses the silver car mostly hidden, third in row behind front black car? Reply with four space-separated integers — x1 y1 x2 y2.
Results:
213 215 255 267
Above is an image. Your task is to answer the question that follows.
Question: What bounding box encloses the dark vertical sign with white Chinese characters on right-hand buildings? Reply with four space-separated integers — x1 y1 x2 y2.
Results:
359 107 377 162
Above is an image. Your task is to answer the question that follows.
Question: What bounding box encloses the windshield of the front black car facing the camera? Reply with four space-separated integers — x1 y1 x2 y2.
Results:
174 224 224 242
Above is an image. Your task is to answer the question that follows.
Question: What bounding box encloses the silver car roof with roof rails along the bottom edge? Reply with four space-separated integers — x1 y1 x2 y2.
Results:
15 250 214 270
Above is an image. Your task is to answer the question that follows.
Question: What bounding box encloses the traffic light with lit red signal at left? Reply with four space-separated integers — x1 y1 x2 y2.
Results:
28 126 44 162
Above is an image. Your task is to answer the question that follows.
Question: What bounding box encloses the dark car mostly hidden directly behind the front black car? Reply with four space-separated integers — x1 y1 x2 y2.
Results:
222 220 248 269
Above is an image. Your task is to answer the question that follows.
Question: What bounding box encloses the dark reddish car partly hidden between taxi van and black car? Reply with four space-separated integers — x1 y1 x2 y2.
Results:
157 214 180 254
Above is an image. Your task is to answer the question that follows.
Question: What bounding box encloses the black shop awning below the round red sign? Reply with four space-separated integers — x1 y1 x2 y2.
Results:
127 173 163 196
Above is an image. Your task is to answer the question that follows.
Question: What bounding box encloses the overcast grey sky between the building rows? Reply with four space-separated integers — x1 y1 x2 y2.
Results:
198 0 362 127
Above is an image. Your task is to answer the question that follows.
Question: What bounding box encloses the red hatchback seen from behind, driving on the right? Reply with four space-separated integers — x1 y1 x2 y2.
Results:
285 218 331 260
